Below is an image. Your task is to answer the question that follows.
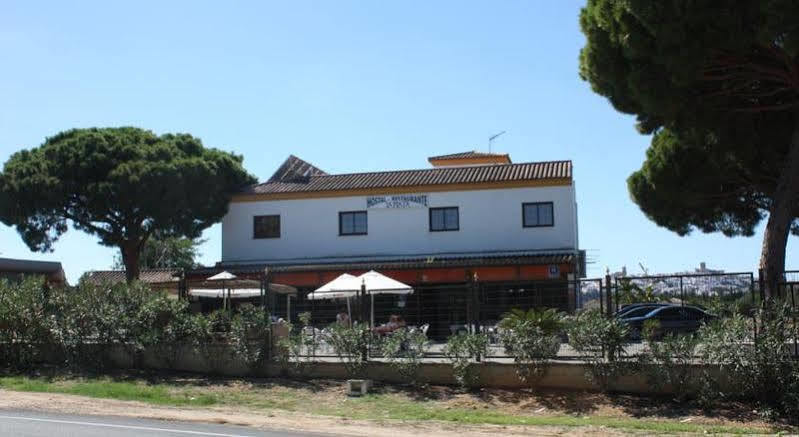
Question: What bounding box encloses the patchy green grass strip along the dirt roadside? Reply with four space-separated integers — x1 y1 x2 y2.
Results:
0 376 778 435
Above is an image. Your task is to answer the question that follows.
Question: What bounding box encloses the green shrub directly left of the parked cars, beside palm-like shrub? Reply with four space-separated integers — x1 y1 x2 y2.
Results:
566 310 631 390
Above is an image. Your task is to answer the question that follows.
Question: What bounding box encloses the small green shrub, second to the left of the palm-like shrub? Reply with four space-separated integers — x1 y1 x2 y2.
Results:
380 328 428 384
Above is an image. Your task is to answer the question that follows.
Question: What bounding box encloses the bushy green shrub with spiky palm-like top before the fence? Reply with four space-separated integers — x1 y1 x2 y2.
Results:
499 309 564 384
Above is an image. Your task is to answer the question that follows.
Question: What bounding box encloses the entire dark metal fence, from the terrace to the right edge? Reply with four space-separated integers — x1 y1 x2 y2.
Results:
195 271 799 359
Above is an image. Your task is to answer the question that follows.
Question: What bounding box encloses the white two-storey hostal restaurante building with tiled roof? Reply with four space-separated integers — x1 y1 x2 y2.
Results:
190 152 584 337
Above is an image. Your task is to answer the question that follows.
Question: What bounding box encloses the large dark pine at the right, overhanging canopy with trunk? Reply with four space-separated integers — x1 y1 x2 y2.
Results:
580 0 799 292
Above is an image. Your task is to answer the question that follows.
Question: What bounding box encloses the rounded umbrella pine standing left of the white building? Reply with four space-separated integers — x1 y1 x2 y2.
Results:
0 127 255 281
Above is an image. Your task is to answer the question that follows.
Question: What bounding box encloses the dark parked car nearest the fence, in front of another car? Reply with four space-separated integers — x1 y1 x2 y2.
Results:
619 304 716 340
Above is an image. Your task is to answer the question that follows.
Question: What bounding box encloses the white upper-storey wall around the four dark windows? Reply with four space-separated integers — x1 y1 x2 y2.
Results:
222 186 577 262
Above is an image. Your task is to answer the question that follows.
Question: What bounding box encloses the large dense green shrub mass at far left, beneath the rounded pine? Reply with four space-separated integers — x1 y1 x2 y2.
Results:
0 278 201 368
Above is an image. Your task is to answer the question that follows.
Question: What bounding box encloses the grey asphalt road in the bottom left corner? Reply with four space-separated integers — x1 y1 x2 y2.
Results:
0 409 332 437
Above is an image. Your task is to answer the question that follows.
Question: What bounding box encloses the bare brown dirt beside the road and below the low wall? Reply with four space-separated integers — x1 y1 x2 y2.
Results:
0 374 788 437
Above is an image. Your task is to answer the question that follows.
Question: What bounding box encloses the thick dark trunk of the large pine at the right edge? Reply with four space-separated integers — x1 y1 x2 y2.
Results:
760 117 799 299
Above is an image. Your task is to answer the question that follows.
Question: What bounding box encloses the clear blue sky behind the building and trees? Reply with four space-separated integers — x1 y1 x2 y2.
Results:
0 0 799 281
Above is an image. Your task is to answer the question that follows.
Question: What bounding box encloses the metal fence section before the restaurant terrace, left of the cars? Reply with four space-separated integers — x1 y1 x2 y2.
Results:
268 279 602 357
